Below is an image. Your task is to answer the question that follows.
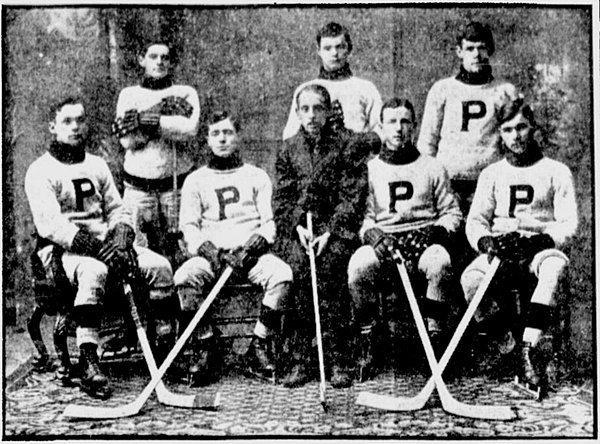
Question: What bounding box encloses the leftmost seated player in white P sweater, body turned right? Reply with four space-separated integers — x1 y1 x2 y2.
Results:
25 98 173 397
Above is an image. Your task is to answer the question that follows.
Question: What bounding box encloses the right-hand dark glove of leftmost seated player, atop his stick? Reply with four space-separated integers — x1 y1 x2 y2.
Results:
98 223 137 277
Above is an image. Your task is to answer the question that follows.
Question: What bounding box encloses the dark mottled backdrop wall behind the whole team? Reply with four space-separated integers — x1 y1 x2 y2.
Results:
2 5 595 374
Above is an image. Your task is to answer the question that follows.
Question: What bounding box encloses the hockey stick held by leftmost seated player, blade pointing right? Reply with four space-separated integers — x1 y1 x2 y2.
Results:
123 281 220 409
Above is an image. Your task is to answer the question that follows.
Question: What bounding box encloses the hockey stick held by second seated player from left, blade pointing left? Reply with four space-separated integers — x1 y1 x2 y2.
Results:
63 267 233 419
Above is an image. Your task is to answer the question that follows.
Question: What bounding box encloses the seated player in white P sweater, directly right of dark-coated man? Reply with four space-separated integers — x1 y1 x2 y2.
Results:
348 98 462 380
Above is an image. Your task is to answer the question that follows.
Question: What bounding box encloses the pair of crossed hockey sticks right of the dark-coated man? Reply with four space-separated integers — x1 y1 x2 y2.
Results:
356 251 517 420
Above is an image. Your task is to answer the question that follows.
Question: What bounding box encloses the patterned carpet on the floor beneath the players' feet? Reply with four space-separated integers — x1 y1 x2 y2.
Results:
4 363 597 439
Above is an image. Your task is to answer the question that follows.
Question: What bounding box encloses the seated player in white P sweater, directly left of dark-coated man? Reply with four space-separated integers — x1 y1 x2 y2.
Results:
175 112 292 385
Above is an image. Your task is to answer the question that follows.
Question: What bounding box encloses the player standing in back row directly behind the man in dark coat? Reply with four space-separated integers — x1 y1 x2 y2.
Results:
283 22 381 140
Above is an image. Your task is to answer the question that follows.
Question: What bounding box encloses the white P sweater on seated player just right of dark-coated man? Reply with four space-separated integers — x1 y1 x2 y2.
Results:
369 156 439 232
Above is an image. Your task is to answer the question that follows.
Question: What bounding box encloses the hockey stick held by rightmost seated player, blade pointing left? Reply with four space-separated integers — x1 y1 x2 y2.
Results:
356 259 500 411
